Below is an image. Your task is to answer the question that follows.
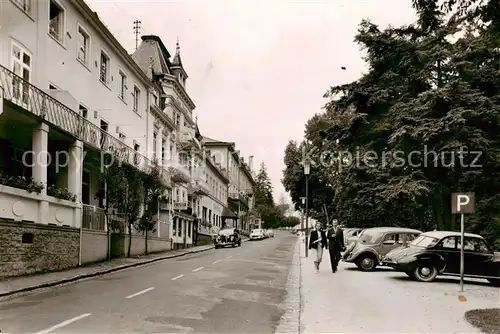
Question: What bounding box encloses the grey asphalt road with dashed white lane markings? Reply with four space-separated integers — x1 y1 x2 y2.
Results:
0 232 296 334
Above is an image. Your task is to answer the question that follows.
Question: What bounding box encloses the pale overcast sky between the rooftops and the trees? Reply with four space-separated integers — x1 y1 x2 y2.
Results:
86 0 415 201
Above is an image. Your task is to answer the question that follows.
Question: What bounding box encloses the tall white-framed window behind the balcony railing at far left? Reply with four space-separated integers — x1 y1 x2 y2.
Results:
12 43 32 105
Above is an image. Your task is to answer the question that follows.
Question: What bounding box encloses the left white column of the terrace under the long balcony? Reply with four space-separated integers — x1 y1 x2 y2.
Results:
32 123 49 224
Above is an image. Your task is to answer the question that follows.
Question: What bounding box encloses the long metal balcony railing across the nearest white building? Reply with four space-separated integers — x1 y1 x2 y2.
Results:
0 65 170 185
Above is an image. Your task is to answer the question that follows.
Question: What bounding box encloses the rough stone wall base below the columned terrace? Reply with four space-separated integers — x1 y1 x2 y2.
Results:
0 220 80 277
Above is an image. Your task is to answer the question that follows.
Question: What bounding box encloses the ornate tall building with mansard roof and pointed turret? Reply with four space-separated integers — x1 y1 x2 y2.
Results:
133 35 210 248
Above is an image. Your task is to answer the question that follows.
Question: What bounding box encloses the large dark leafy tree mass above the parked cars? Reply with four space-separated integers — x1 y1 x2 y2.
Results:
282 0 500 247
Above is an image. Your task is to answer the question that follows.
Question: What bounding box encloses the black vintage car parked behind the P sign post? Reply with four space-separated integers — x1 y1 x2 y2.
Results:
382 231 500 286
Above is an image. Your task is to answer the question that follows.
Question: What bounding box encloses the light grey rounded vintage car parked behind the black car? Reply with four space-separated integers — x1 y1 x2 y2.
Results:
344 227 422 271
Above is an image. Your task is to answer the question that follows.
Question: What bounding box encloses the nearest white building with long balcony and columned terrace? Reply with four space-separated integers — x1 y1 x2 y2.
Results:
0 0 174 241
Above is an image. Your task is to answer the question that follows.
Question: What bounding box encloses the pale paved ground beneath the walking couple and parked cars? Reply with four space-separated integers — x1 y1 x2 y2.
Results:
301 244 499 333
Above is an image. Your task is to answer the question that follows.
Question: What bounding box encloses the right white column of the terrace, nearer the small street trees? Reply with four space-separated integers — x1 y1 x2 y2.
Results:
68 140 83 228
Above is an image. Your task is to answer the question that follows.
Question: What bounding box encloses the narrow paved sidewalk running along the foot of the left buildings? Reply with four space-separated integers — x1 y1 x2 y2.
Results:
0 240 215 298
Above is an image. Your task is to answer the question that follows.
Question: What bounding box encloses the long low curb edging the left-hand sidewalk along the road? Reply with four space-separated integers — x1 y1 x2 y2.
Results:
0 246 215 300
